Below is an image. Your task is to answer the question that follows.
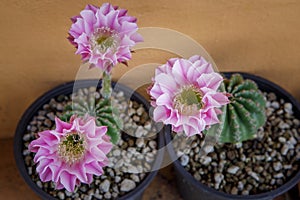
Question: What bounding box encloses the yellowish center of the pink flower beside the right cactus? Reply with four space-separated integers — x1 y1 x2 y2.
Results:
174 85 204 115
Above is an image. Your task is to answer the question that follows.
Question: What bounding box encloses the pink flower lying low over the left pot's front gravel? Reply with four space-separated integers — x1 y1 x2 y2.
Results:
29 116 112 192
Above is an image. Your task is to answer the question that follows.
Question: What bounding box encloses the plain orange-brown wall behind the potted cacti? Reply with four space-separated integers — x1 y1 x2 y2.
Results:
0 0 300 138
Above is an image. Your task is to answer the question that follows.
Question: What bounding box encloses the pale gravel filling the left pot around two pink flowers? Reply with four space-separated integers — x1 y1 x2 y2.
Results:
23 88 158 200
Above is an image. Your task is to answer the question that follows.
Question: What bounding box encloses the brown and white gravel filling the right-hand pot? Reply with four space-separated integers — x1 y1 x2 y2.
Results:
173 93 300 195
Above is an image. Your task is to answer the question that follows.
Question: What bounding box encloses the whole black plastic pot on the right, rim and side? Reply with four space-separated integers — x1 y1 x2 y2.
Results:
165 72 300 200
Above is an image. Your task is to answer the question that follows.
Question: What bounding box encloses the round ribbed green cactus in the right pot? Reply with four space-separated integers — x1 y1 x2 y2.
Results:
219 74 266 143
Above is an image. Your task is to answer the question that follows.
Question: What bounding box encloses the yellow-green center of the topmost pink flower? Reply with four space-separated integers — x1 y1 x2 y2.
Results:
90 27 120 53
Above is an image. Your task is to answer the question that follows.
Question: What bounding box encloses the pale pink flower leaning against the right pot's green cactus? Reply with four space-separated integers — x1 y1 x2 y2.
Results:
149 56 229 136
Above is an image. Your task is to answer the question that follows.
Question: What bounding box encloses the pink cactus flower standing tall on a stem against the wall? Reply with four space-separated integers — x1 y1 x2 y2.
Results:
68 3 143 72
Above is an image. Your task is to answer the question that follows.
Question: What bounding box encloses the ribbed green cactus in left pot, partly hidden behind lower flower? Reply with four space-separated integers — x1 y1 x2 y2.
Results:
63 87 122 144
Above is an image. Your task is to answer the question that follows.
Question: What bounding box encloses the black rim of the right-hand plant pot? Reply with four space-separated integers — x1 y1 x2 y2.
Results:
165 72 300 200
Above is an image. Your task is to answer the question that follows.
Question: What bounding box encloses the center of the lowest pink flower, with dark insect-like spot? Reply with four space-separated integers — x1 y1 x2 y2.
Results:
58 132 86 165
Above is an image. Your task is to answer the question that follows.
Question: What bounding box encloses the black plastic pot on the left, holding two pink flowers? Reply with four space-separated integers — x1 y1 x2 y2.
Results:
14 80 164 200
